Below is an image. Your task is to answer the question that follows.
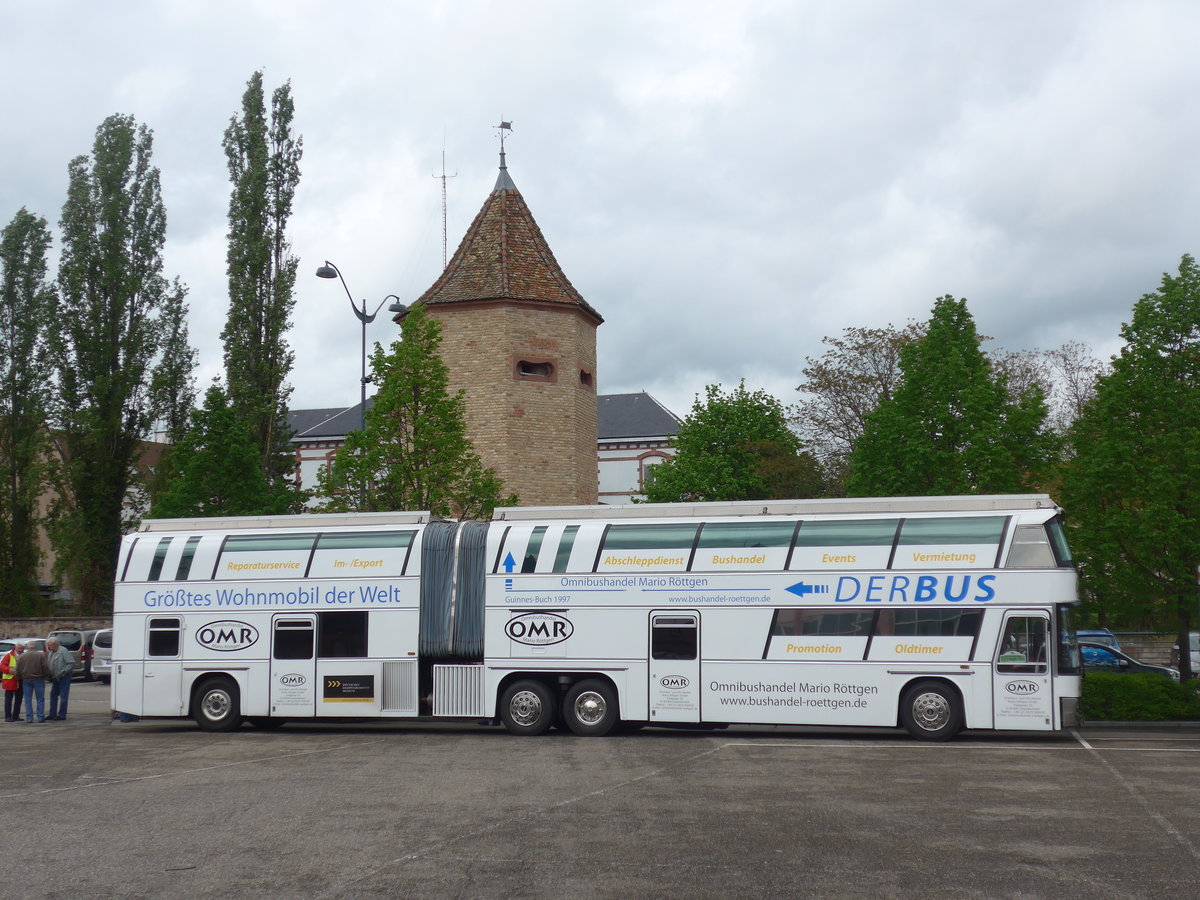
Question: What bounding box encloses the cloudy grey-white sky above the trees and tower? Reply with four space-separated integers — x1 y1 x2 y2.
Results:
0 0 1200 415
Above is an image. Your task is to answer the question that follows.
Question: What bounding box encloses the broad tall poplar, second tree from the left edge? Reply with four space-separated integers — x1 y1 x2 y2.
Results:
49 115 192 613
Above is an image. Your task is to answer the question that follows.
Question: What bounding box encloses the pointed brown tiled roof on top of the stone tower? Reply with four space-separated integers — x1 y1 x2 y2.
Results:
416 160 604 324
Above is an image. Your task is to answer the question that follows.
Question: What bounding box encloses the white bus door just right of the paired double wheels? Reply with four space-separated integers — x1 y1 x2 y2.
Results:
650 610 700 725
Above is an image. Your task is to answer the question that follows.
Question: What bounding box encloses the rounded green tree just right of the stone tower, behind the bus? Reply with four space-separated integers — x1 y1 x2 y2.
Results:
644 382 822 503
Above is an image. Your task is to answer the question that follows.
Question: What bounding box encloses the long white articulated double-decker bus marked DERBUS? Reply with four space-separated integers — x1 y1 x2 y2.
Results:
113 494 1080 739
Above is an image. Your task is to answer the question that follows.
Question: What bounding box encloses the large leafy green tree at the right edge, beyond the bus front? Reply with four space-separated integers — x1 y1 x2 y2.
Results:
1063 256 1200 666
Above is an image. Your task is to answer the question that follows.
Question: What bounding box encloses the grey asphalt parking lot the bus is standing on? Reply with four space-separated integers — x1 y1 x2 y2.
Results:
0 683 1200 898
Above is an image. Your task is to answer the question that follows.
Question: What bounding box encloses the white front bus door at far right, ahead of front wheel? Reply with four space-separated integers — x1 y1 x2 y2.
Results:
992 610 1054 730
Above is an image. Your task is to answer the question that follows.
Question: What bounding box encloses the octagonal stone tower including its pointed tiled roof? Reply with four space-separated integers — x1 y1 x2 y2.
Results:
397 151 604 506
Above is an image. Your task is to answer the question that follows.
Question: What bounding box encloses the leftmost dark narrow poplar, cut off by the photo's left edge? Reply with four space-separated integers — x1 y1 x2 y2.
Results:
0 209 52 616
